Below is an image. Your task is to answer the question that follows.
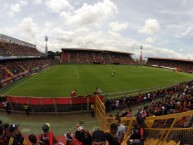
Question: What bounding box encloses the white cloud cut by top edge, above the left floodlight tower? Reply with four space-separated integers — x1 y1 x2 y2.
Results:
46 0 73 13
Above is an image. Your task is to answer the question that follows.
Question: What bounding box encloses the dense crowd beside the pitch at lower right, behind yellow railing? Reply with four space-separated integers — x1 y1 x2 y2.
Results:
105 81 193 117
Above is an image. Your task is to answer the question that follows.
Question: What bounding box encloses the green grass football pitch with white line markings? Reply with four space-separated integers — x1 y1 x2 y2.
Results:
0 64 193 97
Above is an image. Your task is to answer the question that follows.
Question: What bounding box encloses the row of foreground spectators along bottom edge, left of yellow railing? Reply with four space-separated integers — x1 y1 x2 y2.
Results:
0 118 126 145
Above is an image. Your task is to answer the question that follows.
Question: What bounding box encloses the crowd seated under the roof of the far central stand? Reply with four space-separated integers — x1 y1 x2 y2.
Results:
62 51 134 64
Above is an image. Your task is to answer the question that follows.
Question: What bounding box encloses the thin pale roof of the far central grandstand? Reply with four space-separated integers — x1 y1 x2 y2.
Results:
62 48 134 55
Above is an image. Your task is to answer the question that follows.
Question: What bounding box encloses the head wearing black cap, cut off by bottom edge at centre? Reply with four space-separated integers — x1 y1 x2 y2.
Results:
92 130 106 145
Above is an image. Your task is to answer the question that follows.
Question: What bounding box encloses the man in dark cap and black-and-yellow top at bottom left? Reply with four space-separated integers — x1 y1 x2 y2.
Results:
8 124 27 145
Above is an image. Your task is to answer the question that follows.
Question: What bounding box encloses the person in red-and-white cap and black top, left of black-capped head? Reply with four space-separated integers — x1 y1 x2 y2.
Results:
75 126 91 145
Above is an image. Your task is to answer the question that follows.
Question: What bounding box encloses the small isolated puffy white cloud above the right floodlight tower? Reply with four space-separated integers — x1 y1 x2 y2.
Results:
138 18 160 35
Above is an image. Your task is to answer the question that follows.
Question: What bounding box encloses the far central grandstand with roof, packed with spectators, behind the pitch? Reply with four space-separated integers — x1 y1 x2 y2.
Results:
61 48 133 64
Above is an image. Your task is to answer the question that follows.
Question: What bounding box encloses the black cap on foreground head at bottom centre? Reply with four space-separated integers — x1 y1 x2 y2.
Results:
92 130 106 142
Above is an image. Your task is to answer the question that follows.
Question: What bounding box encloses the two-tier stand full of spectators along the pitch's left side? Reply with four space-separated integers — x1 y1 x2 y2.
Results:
0 34 59 88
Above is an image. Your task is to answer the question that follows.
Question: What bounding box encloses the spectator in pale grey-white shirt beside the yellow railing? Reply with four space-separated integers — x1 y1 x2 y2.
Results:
115 117 126 143
